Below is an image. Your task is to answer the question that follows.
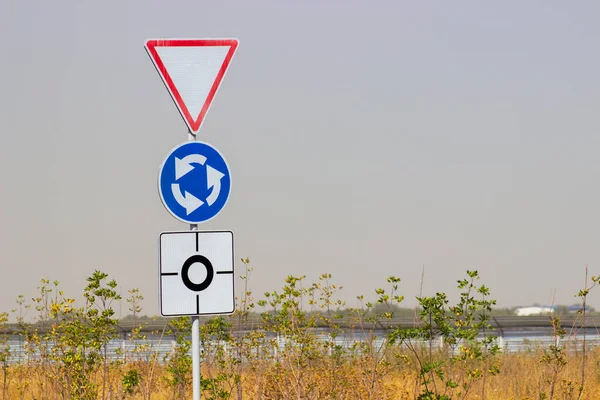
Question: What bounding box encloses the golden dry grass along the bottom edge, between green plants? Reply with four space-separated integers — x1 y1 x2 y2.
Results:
0 349 600 400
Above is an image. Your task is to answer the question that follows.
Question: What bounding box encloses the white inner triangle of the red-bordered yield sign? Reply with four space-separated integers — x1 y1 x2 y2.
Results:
156 46 230 121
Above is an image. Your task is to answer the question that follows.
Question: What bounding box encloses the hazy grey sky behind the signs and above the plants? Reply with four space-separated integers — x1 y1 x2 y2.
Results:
0 0 600 315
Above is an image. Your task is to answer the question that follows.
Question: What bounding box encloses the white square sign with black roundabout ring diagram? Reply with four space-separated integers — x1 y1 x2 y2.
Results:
159 231 235 317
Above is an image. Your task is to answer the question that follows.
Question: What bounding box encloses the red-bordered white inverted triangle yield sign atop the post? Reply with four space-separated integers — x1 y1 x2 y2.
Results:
145 39 238 135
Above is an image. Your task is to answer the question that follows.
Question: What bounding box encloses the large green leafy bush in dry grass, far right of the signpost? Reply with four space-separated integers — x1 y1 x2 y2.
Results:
389 271 500 400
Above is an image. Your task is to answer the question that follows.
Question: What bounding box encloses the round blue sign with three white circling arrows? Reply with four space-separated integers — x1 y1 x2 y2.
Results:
158 141 231 224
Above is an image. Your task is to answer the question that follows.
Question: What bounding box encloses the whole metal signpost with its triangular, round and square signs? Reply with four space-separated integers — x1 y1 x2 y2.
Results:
144 39 238 400
